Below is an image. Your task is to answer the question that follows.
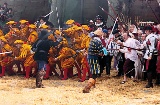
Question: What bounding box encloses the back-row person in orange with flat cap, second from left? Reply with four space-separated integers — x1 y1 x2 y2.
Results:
19 20 29 42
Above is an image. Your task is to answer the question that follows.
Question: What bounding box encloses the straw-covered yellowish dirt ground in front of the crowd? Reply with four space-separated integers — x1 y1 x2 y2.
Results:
0 70 160 105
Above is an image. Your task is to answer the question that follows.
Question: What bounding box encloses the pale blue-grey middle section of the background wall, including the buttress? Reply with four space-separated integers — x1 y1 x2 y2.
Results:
49 0 108 27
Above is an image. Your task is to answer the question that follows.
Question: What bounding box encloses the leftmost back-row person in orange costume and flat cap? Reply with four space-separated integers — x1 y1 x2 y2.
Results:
5 21 20 45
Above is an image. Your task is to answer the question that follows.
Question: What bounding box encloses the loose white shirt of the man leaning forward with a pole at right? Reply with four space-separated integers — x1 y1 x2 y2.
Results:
120 38 138 62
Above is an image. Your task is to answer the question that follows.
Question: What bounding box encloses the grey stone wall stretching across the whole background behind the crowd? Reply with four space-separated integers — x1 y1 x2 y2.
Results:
0 0 160 26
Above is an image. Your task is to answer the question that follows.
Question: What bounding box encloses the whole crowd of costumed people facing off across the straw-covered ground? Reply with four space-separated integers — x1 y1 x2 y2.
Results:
0 15 160 93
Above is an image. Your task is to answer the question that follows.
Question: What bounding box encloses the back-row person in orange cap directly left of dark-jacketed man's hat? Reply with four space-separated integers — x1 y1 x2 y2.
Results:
27 24 38 45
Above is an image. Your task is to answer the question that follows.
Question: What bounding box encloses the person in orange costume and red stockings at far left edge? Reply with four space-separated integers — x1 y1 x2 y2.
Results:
0 36 15 77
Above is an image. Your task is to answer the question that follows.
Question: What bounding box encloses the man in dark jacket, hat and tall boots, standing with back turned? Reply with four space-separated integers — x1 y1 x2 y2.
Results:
32 30 56 88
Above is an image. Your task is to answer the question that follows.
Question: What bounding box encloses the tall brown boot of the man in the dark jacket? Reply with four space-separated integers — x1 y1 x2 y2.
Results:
36 70 46 88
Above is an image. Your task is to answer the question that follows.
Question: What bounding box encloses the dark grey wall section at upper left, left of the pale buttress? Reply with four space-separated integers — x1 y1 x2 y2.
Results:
0 0 50 21
